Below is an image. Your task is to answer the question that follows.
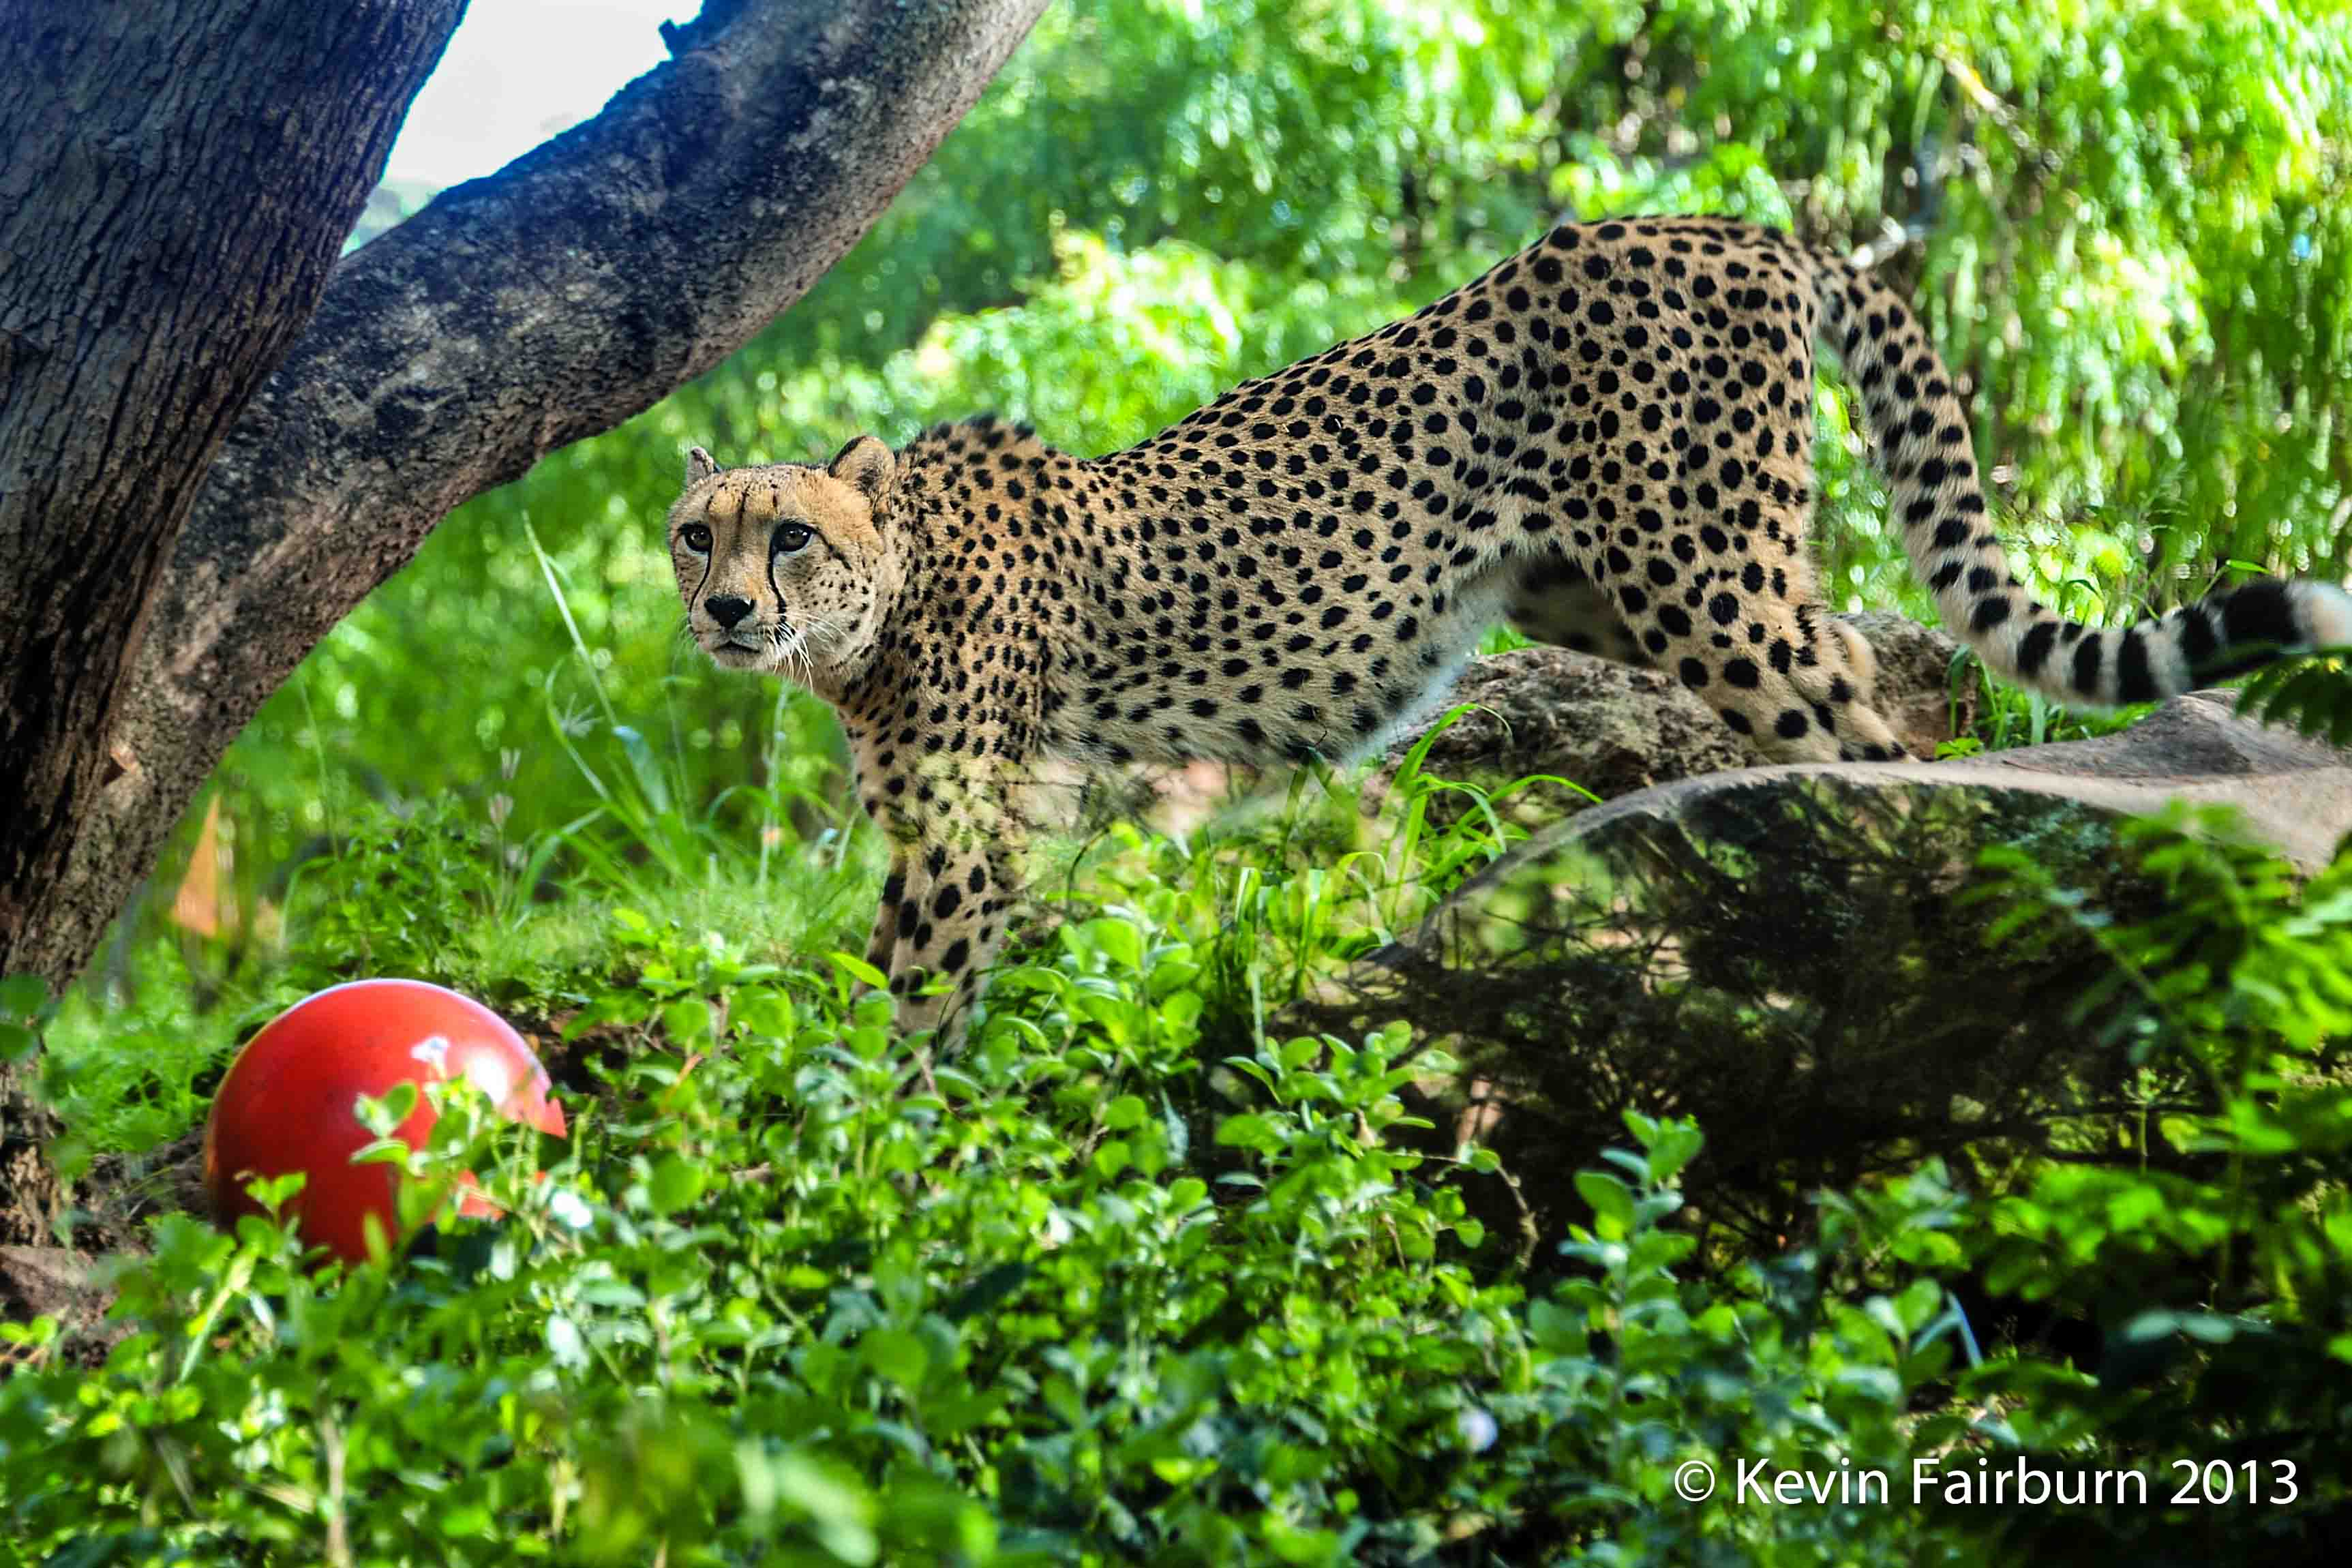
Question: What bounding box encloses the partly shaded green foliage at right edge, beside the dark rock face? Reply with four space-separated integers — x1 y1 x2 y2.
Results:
1966 809 2352 1549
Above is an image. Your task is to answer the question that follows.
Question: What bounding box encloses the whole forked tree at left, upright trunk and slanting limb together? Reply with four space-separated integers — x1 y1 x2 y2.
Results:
0 0 1044 1241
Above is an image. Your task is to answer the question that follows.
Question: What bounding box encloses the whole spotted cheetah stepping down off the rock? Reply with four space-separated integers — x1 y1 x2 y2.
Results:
668 216 2352 1044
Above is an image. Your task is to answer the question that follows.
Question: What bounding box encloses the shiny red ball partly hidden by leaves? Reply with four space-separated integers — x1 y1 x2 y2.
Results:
205 980 564 1263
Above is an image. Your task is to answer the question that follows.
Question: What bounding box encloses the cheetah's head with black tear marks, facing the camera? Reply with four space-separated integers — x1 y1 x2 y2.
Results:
670 435 899 698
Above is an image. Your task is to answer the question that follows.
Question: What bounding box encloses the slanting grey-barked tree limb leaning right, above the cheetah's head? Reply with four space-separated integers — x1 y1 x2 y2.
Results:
0 0 1044 980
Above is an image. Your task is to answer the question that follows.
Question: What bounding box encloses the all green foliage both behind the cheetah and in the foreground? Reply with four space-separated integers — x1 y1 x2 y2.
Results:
22 0 2352 1563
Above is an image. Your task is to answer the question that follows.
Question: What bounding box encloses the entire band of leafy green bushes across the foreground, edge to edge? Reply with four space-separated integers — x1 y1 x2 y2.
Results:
14 783 2352 1563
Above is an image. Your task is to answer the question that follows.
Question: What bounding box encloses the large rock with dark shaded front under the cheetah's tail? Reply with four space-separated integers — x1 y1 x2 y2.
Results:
1284 693 2352 1243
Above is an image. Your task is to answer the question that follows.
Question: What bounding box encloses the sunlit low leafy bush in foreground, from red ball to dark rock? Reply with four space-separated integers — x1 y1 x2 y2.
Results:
0 909 2004 1563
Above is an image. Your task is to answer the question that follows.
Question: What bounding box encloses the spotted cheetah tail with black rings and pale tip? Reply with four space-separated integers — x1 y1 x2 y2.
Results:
1813 254 2352 708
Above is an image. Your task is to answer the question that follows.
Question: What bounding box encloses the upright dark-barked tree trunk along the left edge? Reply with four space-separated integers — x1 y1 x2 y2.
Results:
0 0 464 1241
